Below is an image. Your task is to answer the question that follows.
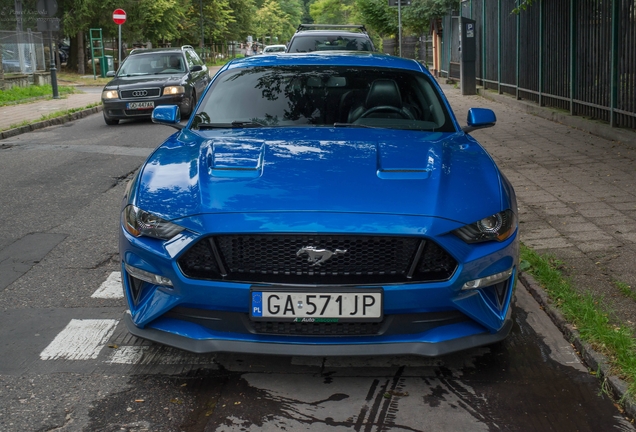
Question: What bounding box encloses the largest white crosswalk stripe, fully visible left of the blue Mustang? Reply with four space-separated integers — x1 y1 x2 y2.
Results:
40 319 119 360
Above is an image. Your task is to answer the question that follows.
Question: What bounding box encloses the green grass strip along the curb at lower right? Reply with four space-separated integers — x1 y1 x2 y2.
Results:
520 241 636 395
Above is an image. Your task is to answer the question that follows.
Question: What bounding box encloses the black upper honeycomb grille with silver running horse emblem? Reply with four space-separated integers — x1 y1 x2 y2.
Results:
178 234 457 285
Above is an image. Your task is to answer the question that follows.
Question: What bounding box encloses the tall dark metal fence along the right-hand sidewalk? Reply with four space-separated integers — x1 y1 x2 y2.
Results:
440 0 636 129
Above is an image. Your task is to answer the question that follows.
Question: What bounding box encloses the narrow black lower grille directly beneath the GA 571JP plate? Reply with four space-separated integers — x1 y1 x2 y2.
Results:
250 321 382 336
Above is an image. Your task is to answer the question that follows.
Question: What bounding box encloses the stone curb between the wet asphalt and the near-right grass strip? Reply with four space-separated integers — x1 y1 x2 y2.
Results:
519 273 636 419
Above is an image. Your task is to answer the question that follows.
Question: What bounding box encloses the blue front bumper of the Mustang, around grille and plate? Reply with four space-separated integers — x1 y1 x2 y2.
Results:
120 215 519 356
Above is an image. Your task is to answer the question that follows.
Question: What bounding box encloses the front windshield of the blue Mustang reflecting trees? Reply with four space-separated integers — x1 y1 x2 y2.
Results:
192 66 455 132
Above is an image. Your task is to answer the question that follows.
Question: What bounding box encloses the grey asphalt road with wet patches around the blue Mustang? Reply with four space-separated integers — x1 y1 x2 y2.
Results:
0 115 634 432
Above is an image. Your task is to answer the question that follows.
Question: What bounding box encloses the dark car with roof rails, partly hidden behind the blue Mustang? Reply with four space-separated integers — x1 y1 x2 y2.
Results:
286 24 375 53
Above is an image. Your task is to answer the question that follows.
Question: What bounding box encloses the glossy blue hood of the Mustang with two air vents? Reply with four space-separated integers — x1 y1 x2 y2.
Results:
137 128 503 223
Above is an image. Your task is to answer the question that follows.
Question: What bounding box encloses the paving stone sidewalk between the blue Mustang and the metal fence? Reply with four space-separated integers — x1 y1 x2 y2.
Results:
441 80 636 328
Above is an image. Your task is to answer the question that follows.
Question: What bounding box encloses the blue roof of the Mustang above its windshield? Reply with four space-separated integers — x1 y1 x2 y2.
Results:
222 51 430 75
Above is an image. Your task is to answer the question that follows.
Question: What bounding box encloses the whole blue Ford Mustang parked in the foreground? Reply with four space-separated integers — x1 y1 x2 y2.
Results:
120 52 518 356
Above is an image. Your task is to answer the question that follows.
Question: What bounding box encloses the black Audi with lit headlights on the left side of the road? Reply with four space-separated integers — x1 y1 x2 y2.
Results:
102 45 211 125
